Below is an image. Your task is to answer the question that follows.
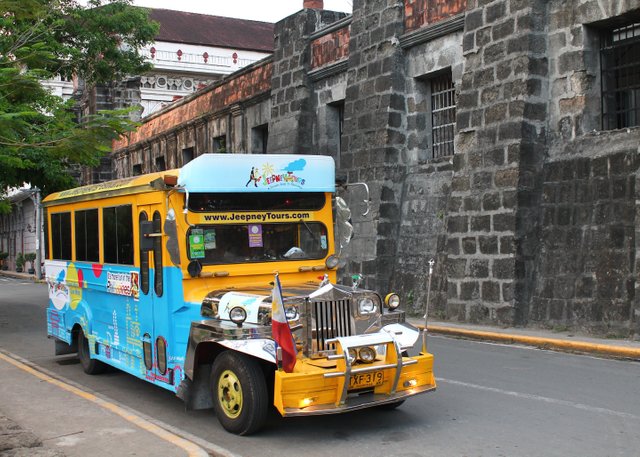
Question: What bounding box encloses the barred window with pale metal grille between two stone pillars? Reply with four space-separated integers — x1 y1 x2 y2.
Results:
431 73 456 158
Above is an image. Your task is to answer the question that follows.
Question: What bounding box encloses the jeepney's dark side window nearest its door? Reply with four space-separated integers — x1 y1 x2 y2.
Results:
102 205 133 265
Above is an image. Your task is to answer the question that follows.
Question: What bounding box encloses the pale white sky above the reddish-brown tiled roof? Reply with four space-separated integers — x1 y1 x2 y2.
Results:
128 0 353 22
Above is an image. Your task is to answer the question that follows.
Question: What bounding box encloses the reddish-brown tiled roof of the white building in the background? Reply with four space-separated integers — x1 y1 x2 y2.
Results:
149 8 273 52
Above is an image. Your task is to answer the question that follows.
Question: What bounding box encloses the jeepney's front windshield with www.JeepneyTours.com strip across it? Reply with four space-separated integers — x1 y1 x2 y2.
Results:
182 192 329 265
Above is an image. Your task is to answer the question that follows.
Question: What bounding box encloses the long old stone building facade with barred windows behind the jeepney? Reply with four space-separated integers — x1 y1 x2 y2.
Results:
113 0 640 334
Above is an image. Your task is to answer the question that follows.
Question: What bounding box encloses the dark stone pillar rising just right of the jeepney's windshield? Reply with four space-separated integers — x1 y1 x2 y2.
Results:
340 0 406 293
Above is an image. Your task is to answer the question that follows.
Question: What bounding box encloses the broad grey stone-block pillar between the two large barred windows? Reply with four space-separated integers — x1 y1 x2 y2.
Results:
447 0 548 324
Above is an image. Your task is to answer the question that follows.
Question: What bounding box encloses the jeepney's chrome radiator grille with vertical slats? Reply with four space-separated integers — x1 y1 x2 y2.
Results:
311 300 353 353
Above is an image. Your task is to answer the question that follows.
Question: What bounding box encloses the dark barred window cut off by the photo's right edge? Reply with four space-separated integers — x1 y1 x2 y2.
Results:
600 23 640 130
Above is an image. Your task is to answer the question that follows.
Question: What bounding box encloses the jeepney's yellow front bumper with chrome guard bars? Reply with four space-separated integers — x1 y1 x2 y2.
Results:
274 332 436 417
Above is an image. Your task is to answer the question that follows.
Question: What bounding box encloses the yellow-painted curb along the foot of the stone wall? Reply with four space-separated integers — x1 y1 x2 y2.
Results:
419 325 640 359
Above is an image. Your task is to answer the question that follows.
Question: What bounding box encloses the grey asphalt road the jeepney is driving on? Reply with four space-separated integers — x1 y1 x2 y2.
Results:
0 277 640 457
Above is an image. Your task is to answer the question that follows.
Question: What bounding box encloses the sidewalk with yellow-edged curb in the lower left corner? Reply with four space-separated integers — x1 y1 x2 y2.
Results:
0 351 214 457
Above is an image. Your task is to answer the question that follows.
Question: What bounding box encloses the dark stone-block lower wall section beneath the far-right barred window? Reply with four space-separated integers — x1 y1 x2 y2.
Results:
530 149 638 336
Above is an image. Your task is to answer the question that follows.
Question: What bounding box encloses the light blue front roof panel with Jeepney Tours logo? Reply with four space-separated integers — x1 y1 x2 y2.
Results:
178 154 335 192
